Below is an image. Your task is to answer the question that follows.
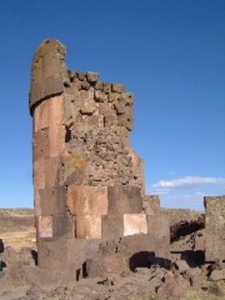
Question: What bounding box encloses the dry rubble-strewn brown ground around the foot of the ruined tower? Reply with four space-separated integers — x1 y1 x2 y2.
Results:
0 209 225 300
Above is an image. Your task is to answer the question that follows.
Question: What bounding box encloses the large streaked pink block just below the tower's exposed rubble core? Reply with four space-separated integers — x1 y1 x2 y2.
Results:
67 185 108 216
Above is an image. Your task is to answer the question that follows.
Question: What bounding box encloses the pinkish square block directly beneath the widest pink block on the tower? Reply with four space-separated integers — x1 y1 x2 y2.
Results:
75 215 102 239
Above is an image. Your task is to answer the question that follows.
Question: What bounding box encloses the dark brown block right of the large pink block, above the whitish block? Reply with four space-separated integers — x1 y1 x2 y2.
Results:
108 185 142 215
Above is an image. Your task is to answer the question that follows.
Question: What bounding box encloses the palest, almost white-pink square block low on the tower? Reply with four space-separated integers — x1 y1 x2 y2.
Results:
123 214 148 236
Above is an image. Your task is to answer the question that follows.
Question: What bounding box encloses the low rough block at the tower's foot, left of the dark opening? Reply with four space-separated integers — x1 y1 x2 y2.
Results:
87 254 129 277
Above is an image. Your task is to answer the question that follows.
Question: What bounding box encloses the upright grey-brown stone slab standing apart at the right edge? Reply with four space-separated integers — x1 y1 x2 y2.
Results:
204 196 225 261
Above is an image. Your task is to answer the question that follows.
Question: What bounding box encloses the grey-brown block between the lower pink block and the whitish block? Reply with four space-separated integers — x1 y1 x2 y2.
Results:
102 214 124 240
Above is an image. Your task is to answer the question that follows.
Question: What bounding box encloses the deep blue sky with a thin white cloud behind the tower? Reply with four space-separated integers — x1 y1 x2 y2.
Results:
0 0 225 209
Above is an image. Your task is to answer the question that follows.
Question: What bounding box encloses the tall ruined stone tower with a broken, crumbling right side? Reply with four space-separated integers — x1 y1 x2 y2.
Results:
30 40 225 280
